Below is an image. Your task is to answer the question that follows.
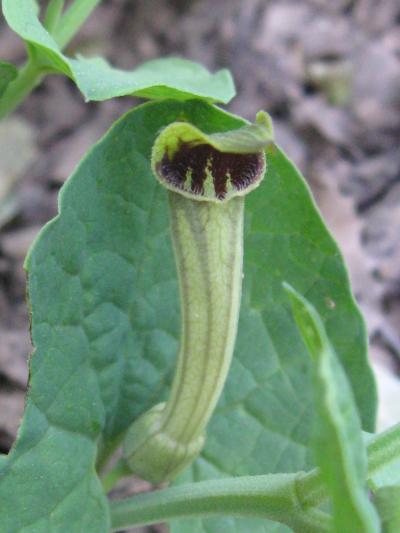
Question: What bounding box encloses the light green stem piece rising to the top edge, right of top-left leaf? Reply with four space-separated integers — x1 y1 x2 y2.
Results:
53 0 101 50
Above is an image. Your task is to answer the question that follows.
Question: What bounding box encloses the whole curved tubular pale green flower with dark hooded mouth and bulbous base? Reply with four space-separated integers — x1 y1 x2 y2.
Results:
124 113 272 483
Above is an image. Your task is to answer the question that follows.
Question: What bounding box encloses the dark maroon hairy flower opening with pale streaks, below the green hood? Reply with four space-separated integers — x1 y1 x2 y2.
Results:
156 141 265 201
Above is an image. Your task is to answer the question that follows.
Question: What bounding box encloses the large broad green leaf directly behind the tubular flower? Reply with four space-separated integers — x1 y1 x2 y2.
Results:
0 101 375 533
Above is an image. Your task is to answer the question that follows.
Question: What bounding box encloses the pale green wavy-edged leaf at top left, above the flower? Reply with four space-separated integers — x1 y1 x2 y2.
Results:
2 0 235 103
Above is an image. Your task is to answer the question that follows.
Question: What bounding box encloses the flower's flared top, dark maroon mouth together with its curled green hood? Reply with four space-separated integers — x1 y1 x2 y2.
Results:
151 111 273 202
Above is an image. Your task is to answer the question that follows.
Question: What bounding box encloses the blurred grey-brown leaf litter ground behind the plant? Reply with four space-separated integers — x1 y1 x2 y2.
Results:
0 0 400 508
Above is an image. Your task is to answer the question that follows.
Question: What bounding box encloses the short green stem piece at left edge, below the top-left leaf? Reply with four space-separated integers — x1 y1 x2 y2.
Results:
0 59 44 119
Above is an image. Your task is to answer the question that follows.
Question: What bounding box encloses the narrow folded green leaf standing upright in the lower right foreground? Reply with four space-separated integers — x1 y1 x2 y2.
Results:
285 284 380 533
